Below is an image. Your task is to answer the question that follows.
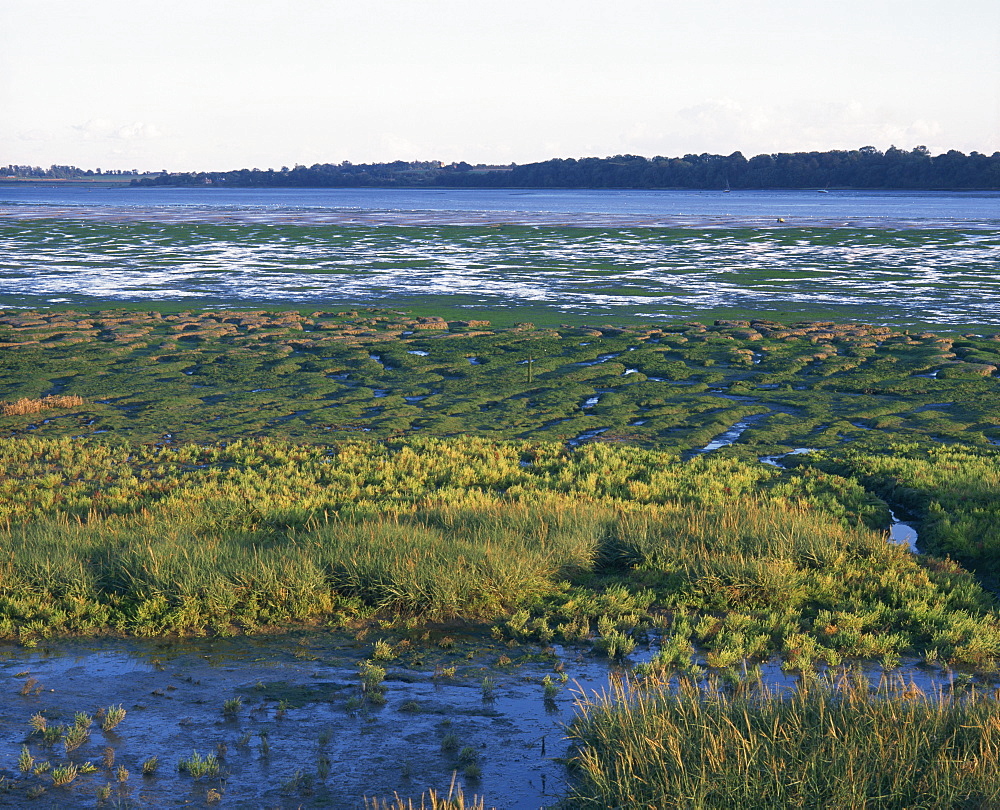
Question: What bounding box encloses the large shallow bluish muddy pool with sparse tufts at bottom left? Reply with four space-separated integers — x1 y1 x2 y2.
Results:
0 633 632 810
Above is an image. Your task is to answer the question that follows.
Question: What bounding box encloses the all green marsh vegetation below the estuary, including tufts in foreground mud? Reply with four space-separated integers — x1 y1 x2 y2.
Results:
0 310 1000 807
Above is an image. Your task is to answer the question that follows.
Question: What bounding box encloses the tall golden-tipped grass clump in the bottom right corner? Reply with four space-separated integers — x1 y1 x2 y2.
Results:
563 677 1000 810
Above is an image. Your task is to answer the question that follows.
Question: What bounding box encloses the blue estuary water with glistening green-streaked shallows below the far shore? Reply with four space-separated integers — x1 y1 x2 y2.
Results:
0 185 1000 328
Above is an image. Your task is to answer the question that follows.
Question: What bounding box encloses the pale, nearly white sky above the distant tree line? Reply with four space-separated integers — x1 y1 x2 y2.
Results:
0 0 1000 171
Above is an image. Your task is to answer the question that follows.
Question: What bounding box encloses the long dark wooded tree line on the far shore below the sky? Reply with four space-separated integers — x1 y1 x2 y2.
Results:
133 146 1000 189
